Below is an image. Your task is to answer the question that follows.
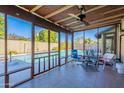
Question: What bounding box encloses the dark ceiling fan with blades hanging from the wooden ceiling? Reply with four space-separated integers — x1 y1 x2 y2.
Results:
68 5 89 25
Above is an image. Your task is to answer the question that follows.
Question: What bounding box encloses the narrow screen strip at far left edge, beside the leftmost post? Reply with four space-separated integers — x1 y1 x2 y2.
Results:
0 13 5 87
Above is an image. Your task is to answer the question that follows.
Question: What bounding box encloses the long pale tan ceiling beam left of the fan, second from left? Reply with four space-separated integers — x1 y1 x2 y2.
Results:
44 5 74 18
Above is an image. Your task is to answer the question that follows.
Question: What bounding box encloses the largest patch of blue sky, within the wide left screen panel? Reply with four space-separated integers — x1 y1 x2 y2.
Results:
7 16 32 38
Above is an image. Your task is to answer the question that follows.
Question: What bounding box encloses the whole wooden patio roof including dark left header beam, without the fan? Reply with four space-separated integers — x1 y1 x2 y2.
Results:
0 5 124 32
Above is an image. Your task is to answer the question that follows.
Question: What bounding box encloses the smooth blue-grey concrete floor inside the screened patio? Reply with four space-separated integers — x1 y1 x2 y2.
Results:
17 62 124 88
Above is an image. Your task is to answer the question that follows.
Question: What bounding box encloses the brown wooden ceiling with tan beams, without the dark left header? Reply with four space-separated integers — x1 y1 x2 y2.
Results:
17 5 124 31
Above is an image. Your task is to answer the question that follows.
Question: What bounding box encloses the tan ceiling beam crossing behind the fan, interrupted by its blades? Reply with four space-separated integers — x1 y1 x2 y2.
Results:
55 5 107 23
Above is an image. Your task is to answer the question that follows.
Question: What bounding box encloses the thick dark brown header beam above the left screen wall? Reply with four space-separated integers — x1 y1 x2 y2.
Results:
0 5 70 32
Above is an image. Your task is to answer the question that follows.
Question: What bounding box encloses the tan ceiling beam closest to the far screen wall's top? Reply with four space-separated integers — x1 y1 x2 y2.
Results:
74 18 121 32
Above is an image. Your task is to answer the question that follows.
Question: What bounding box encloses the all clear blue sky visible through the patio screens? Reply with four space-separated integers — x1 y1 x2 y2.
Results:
7 15 110 42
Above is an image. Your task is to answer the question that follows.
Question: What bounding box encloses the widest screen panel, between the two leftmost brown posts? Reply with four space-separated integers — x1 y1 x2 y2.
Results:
7 15 32 87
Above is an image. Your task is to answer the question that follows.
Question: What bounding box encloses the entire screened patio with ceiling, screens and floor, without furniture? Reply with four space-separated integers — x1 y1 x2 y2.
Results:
0 5 124 88
